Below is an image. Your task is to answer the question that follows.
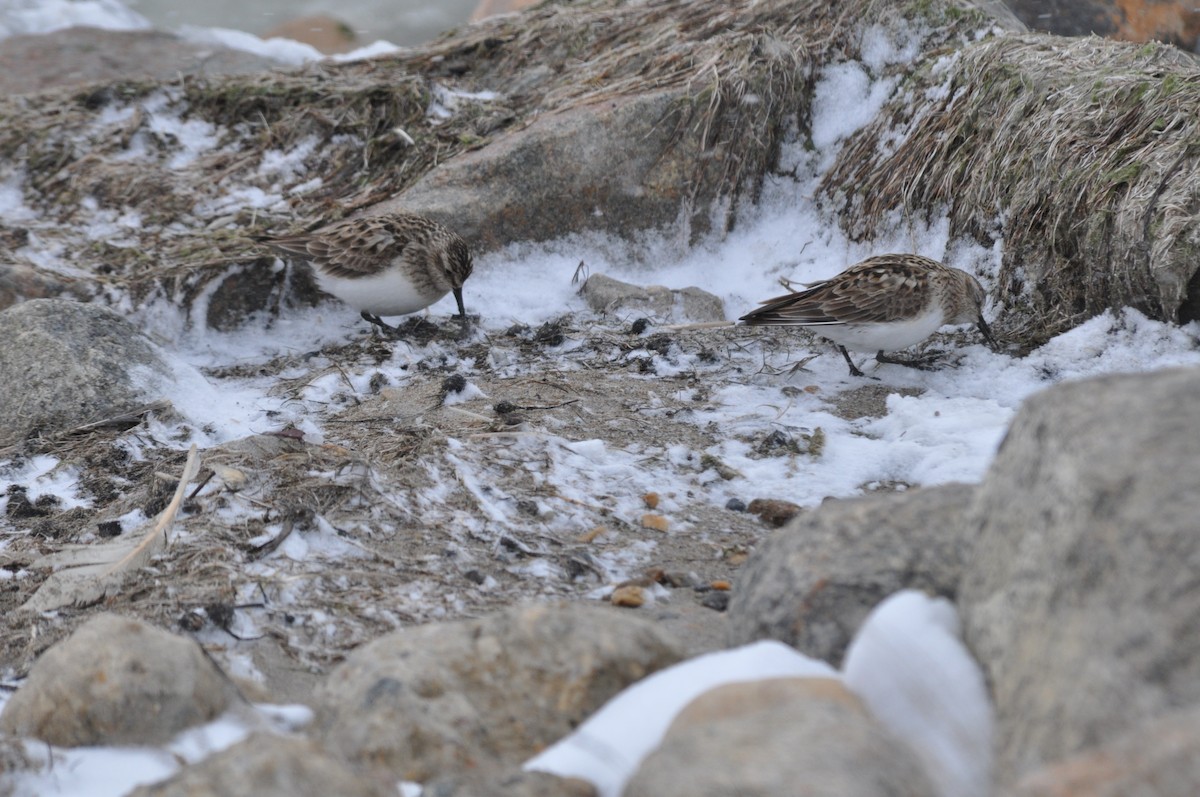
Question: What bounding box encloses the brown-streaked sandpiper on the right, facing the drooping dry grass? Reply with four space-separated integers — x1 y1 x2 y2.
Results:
739 254 995 377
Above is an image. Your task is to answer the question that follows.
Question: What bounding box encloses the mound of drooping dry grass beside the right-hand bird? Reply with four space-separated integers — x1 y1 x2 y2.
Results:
822 35 1200 343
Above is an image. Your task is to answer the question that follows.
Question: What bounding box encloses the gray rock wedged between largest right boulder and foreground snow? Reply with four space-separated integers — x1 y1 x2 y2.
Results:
728 485 974 666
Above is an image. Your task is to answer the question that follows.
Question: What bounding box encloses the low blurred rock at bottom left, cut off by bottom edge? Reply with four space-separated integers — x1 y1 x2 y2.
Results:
130 733 397 797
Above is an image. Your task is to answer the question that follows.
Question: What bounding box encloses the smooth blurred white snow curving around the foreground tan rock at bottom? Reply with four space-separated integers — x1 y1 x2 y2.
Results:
524 591 991 797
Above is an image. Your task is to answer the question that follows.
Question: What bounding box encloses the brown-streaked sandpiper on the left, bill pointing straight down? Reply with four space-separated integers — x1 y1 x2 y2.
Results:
258 214 474 330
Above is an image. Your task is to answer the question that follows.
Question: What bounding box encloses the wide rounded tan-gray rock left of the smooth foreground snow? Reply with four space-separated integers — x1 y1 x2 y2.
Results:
316 605 682 781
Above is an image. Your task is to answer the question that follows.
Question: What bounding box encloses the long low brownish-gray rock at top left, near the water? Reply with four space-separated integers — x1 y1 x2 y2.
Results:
0 26 278 95
